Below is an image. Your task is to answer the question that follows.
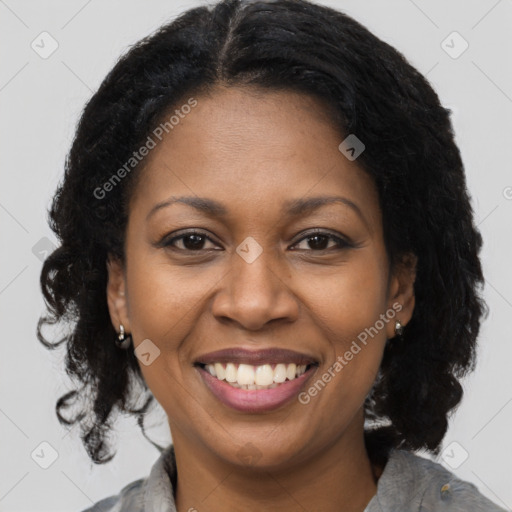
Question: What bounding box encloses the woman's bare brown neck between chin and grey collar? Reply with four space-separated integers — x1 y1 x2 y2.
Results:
172 414 381 512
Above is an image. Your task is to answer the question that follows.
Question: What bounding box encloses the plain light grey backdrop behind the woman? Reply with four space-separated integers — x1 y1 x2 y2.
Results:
0 0 512 512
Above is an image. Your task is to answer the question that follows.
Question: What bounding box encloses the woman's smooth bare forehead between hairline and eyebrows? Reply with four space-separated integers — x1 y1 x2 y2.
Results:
130 87 379 228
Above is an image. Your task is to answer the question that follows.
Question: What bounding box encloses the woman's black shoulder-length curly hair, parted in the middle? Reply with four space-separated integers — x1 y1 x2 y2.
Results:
37 0 488 464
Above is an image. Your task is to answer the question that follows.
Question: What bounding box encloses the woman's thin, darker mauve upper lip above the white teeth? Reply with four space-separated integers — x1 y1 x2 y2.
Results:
195 347 318 366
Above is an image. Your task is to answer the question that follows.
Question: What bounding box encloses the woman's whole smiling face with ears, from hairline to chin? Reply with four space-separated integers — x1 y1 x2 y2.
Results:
108 88 414 468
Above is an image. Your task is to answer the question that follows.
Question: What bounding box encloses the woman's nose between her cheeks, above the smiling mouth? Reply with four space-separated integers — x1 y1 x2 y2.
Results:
212 245 299 331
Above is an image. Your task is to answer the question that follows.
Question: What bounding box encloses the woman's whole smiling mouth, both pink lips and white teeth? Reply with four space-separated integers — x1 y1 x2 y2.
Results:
194 349 319 413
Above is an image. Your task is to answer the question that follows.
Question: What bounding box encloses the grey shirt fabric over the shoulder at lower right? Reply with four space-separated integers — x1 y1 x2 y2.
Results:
367 450 504 512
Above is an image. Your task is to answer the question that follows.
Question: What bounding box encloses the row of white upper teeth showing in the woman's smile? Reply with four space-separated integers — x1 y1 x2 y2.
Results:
205 363 306 389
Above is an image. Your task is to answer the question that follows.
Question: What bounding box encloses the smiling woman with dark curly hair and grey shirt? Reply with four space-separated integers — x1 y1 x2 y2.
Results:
38 0 506 512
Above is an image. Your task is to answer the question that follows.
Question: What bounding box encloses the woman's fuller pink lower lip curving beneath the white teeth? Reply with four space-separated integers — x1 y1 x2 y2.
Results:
196 365 317 412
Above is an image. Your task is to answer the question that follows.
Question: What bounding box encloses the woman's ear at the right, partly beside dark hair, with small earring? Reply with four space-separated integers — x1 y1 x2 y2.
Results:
386 253 418 339
